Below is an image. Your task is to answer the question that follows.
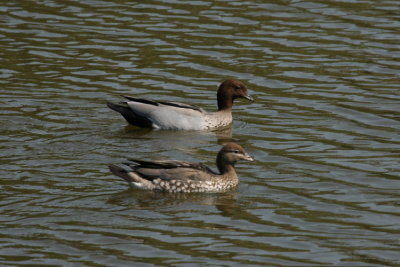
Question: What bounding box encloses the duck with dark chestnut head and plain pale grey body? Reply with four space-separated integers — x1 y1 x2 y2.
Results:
107 79 254 130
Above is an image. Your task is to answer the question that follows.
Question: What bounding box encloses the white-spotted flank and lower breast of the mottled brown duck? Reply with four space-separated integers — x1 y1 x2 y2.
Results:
153 179 238 193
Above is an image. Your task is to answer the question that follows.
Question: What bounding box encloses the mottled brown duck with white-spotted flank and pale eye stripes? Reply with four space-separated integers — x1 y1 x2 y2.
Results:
109 143 254 193
